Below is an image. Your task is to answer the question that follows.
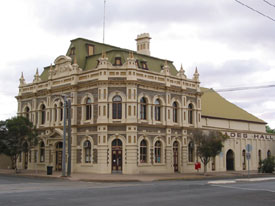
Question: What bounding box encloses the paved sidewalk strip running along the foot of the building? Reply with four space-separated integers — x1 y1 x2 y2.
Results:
0 169 275 182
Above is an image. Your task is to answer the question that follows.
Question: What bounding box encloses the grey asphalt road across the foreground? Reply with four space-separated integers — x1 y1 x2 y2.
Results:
0 175 275 206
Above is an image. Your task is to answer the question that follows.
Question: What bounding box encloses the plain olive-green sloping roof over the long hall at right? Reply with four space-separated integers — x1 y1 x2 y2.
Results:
201 88 266 124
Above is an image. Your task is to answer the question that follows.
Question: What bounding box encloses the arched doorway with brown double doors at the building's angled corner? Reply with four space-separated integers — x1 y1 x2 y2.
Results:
112 139 123 172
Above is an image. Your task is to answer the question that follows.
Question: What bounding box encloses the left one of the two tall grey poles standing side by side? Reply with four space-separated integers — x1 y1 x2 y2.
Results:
62 95 67 177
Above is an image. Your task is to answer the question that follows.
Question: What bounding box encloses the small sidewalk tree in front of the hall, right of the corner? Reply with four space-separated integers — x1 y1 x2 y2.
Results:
191 129 229 174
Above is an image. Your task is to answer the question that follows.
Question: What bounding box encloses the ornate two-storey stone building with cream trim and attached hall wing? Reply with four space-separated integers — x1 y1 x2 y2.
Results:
16 33 275 174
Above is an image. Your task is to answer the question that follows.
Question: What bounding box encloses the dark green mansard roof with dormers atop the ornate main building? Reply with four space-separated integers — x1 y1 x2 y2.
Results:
40 38 177 81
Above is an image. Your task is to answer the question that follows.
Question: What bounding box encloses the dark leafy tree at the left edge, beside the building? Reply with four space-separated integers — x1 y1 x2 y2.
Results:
0 117 38 172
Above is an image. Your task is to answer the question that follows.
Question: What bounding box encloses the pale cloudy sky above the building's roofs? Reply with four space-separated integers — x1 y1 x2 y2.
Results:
0 0 275 128
